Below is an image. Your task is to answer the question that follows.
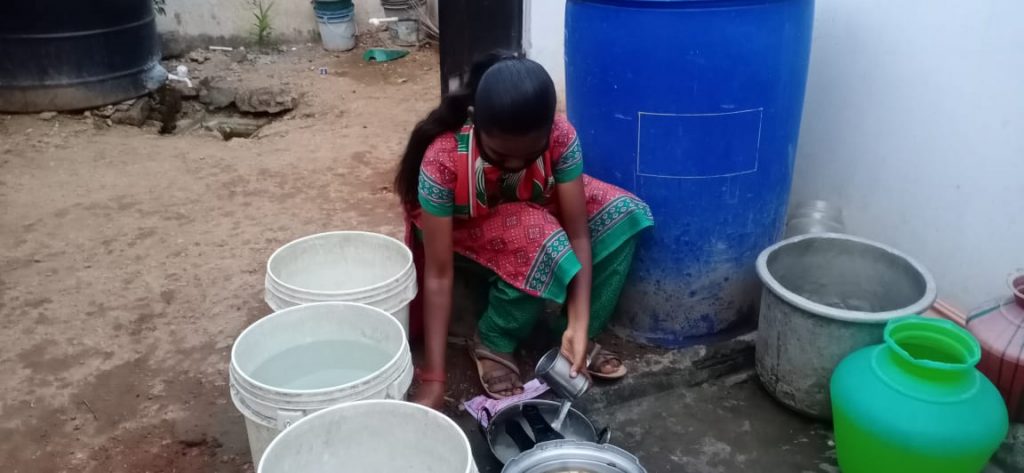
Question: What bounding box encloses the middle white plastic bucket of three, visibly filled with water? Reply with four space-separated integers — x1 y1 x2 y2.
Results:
229 302 413 464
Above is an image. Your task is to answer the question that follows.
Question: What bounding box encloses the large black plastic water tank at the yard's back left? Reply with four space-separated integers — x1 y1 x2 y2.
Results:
0 0 167 112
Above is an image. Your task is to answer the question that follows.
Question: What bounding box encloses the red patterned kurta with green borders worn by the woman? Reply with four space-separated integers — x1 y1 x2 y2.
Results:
409 116 653 335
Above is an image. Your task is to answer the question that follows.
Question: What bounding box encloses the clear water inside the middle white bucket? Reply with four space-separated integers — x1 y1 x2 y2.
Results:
249 340 393 390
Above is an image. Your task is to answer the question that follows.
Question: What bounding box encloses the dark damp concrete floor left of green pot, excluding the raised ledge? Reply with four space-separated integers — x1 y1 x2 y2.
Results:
463 372 839 473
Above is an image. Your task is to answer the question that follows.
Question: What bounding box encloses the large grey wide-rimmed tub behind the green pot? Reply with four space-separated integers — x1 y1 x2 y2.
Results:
756 233 936 419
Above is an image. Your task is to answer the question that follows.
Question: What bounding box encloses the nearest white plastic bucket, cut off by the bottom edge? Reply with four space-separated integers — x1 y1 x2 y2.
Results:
257 400 477 473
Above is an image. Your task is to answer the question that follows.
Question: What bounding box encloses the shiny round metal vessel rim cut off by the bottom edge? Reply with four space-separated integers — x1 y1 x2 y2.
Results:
502 440 647 473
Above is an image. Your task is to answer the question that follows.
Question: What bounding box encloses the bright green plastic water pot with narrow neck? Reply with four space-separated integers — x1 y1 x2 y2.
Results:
830 316 1009 473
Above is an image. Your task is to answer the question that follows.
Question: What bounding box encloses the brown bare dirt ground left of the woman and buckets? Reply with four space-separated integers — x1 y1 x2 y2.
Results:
0 45 439 473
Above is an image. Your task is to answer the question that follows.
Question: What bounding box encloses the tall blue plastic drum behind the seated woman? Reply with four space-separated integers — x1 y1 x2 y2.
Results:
565 0 814 347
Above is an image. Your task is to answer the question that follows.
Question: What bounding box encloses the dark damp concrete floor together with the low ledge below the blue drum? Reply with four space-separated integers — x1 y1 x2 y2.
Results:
457 337 1024 473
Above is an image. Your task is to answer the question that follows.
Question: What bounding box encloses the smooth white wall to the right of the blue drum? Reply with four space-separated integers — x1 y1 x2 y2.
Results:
793 0 1024 309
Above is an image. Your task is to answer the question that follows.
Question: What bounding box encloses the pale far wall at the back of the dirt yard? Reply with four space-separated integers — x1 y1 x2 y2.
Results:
157 0 384 41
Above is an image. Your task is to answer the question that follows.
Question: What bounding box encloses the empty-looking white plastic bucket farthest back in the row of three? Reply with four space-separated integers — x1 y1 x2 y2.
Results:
265 231 417 333
